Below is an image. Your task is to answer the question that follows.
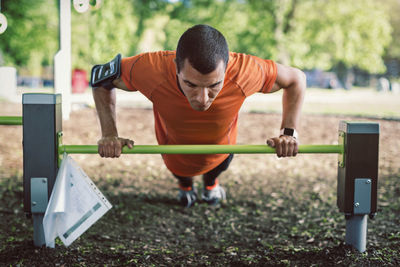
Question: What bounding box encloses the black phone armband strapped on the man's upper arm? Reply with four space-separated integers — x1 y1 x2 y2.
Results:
90 54 121 90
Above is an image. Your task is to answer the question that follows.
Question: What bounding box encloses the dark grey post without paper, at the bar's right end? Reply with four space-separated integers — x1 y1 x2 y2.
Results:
337 121 379 252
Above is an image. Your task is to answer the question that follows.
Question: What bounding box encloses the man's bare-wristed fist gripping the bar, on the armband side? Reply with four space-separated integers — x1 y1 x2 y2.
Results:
97 136 134 158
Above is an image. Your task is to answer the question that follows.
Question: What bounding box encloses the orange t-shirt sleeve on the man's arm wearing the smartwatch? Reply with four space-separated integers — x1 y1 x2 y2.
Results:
234 55 277 96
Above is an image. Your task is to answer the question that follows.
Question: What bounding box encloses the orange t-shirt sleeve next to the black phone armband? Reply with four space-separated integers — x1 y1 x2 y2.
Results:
121 53 154 100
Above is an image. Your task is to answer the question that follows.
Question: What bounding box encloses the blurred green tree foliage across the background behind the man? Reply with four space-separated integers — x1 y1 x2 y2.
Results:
0 0 400 73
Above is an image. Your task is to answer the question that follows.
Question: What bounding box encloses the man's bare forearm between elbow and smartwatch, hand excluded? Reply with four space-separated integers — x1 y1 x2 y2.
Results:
281 71 306 129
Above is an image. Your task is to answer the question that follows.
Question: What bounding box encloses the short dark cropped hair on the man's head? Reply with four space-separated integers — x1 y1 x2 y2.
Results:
176 24 229 74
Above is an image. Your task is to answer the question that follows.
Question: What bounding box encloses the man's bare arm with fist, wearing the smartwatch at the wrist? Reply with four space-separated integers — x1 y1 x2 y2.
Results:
267 63 306 157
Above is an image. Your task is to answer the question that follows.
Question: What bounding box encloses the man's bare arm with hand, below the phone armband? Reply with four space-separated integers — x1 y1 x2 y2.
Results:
92 78 134 158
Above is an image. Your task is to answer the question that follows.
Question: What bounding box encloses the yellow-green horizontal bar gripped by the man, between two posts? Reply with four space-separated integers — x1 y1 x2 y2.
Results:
59 145 344 154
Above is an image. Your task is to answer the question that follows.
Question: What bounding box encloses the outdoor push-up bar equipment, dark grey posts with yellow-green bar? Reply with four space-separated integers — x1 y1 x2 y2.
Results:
0 94 379 252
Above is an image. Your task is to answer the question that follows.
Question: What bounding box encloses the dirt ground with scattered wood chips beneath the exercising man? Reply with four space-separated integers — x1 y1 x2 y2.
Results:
0 103 400 266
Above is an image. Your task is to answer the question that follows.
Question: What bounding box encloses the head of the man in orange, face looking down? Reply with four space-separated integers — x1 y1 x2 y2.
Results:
175 25 229 111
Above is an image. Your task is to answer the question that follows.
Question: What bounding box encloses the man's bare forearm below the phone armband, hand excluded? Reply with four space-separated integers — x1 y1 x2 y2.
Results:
93 87 118 137
